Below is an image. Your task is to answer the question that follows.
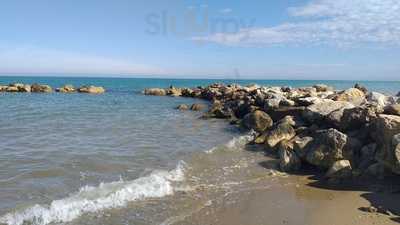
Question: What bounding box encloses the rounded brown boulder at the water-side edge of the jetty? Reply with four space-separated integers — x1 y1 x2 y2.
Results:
242 110 273 133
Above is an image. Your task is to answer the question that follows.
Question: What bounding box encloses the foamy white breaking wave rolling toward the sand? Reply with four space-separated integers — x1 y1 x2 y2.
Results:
0 162 185 225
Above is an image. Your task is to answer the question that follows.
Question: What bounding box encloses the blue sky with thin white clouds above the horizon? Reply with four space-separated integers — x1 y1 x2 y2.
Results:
0 0 400 80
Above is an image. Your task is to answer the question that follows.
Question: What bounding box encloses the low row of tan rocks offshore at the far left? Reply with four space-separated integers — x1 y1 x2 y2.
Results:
0 83 106 94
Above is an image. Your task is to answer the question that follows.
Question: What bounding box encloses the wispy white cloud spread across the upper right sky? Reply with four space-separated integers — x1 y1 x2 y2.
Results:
193 0 400 46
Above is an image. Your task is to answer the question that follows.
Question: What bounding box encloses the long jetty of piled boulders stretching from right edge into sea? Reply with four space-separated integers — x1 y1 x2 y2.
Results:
144 84 400 180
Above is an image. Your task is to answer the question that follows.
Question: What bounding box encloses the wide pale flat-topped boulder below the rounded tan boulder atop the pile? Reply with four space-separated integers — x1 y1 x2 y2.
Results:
303 99 355 122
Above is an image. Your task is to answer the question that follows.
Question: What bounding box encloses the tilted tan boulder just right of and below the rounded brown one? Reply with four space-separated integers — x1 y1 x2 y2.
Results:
265 122 296 149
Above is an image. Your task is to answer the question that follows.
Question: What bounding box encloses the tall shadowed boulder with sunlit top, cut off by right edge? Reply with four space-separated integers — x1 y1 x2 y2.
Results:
373 114 400 174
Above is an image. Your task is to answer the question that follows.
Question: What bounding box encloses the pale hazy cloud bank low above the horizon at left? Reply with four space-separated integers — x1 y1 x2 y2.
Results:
0 47 163 75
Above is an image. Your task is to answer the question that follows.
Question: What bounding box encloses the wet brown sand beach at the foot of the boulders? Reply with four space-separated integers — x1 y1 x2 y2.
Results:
170 142 400 225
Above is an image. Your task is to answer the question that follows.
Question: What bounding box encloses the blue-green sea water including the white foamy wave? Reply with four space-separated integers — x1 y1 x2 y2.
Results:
0 77 400 224
